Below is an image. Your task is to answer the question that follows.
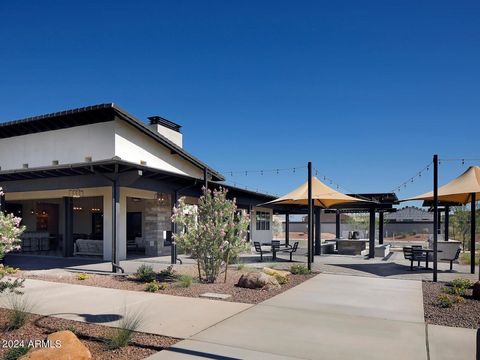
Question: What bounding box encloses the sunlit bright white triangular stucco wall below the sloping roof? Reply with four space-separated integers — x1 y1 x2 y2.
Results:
115 120 203 179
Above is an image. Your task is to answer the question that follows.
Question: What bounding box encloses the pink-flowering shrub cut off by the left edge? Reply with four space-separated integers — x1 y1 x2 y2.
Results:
0 187 25 293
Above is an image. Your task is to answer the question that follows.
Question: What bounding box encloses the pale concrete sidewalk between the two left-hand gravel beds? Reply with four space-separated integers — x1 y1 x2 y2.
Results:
0 279 252 338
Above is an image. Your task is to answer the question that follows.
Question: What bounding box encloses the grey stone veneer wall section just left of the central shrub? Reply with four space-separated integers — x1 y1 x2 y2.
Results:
143 195 172 256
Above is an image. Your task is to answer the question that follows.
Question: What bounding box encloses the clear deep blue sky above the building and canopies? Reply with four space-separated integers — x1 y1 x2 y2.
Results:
0 0 480 197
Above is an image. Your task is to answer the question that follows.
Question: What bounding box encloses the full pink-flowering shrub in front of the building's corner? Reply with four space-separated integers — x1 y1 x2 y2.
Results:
172 188 249 283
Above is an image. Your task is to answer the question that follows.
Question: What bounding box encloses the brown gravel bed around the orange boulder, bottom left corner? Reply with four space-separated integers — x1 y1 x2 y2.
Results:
0 308 179 360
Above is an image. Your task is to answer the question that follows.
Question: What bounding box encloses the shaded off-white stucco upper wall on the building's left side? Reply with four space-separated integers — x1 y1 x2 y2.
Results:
0 121 115 170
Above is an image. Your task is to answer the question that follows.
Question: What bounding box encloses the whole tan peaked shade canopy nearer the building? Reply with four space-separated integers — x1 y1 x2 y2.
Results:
264 177 367 208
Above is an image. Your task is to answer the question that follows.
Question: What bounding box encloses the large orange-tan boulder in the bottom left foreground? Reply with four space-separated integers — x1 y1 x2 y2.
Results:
20 330 92 360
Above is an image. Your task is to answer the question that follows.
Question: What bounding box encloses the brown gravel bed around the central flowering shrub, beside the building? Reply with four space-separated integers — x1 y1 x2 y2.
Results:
16 268 317 304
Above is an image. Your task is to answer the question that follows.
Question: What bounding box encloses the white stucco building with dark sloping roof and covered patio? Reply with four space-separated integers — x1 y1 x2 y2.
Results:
0 104 274 262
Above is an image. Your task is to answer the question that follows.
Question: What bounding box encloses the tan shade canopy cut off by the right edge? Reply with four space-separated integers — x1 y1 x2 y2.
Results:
404 166 480 204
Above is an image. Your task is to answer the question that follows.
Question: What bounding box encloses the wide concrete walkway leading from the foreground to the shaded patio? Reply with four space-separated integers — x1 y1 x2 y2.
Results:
149 274 475 360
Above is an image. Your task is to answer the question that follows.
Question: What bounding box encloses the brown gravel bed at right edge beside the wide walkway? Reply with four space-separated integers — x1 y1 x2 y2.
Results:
423 281 480 329
